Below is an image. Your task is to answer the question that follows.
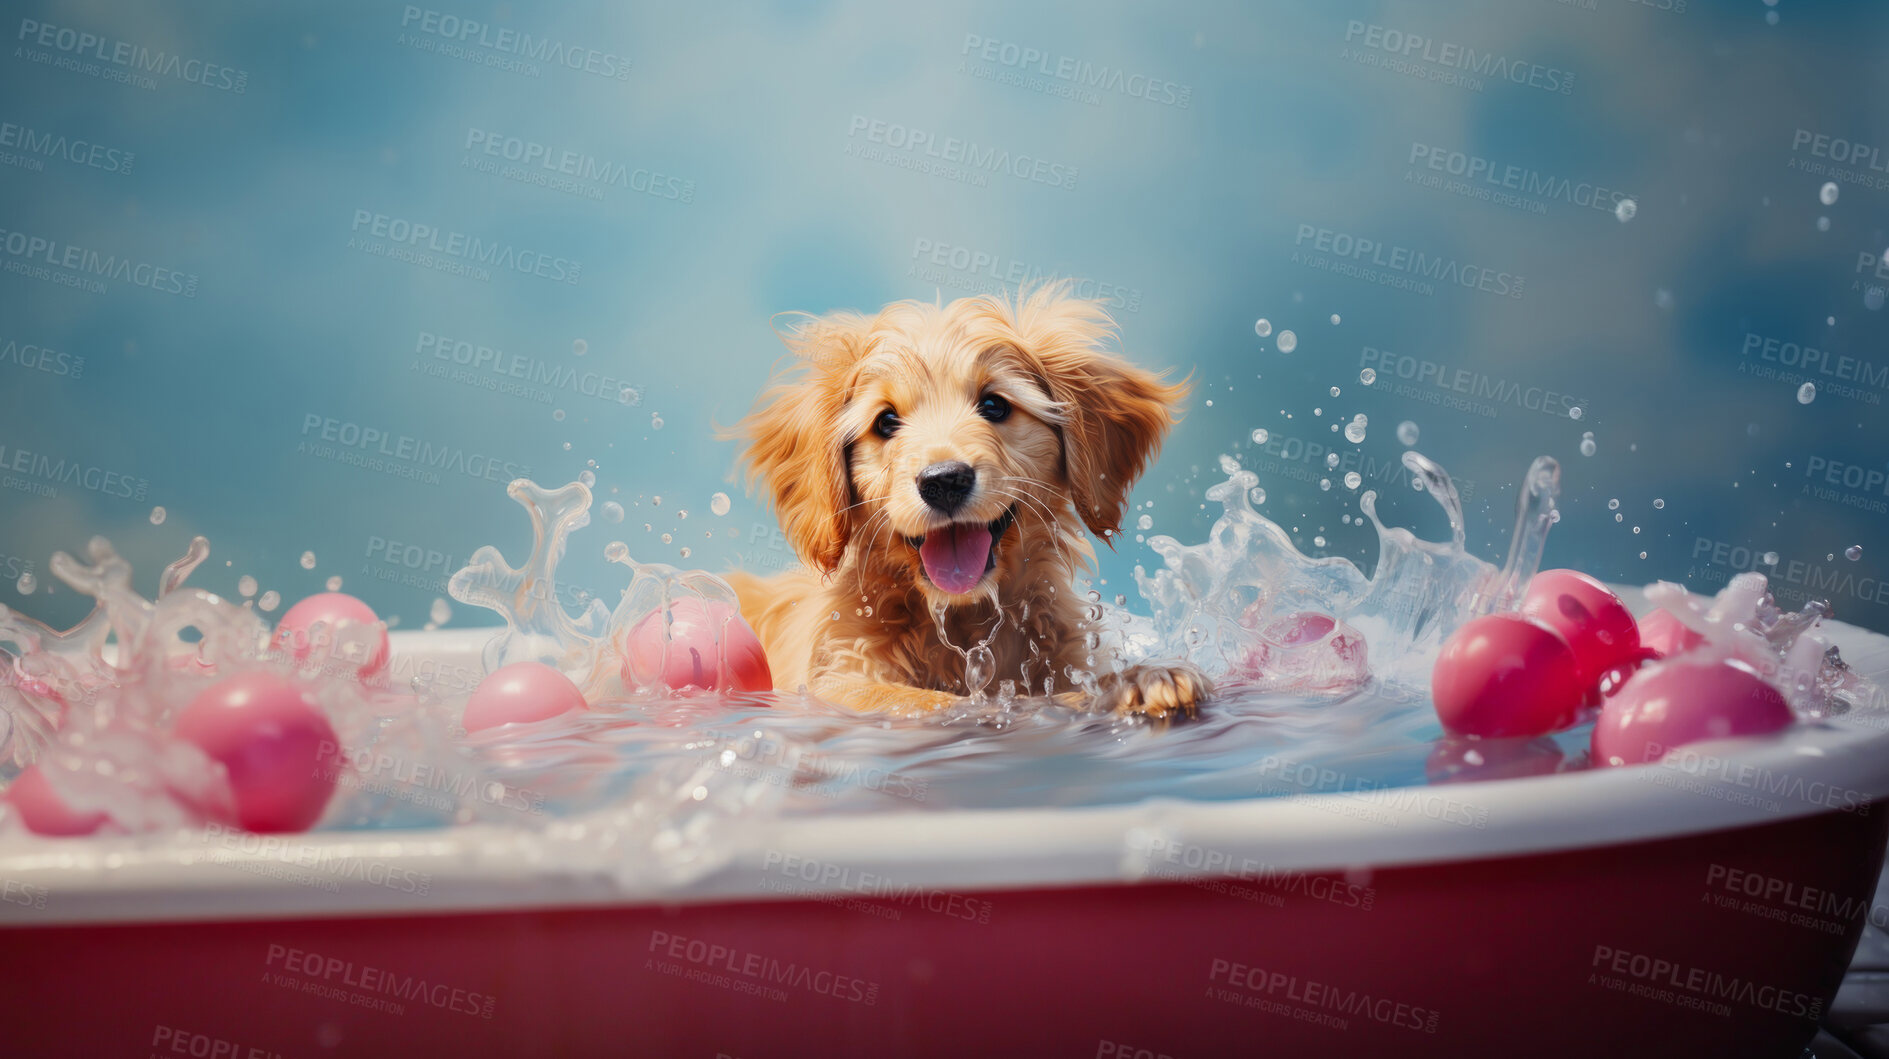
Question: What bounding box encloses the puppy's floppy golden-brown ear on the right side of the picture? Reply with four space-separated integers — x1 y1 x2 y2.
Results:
1014 285 1190 547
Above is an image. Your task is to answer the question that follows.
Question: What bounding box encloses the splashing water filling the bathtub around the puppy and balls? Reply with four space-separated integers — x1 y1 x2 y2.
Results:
0 403 1881 878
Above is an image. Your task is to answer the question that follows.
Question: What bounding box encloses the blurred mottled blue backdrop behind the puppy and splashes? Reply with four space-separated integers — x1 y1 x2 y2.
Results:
0 0 1889 630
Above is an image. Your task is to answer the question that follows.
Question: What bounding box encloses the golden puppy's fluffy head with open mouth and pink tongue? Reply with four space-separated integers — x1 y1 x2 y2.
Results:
739 283 1188 604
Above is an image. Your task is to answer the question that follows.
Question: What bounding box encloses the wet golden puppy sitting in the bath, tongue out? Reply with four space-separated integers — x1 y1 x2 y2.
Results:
729 283 1209 717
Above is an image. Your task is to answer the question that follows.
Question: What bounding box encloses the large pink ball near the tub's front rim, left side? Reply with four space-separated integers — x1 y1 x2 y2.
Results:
176 670 340 832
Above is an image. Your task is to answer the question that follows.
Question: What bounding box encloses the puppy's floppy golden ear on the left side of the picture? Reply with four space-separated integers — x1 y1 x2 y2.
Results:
733 313 869 574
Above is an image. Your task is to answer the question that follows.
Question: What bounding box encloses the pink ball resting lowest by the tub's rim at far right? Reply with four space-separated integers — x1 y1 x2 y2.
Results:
1594 661 1795 765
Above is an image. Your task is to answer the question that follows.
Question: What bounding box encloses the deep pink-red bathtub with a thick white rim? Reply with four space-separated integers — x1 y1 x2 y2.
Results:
0 600 1889 1059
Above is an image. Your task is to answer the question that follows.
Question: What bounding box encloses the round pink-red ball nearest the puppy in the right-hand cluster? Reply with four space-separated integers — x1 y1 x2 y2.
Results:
1430 614 1587 736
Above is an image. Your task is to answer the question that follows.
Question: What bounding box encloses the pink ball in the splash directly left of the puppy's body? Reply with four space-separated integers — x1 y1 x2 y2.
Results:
623 597 774 691
